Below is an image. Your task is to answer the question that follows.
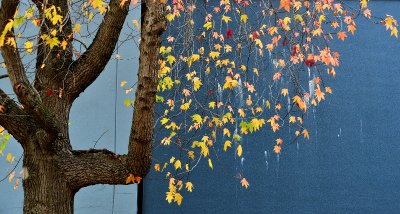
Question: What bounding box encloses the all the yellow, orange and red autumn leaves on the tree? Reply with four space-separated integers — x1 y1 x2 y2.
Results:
0 0 398 209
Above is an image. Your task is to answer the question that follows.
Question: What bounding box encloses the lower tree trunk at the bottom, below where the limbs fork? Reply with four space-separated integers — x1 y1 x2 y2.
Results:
23 153 75 214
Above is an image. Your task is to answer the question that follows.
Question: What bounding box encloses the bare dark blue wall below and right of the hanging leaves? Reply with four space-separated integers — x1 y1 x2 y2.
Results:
144 1 400 214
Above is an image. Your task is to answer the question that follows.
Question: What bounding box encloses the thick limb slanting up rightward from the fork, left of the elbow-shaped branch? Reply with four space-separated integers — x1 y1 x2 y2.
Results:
65 0 129 101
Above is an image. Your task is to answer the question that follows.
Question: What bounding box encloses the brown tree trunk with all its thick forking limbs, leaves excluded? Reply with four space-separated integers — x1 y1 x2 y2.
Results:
0 0 166 214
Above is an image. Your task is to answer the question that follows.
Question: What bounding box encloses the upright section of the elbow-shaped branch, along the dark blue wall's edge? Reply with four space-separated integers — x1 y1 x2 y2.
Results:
128 0 166 175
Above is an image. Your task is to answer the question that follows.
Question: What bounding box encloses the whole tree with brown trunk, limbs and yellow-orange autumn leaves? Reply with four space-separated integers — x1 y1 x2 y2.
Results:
0 0 397 213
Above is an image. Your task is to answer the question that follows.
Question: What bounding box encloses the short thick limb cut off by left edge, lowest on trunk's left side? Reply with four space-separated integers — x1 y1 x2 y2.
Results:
0 89 37 144
